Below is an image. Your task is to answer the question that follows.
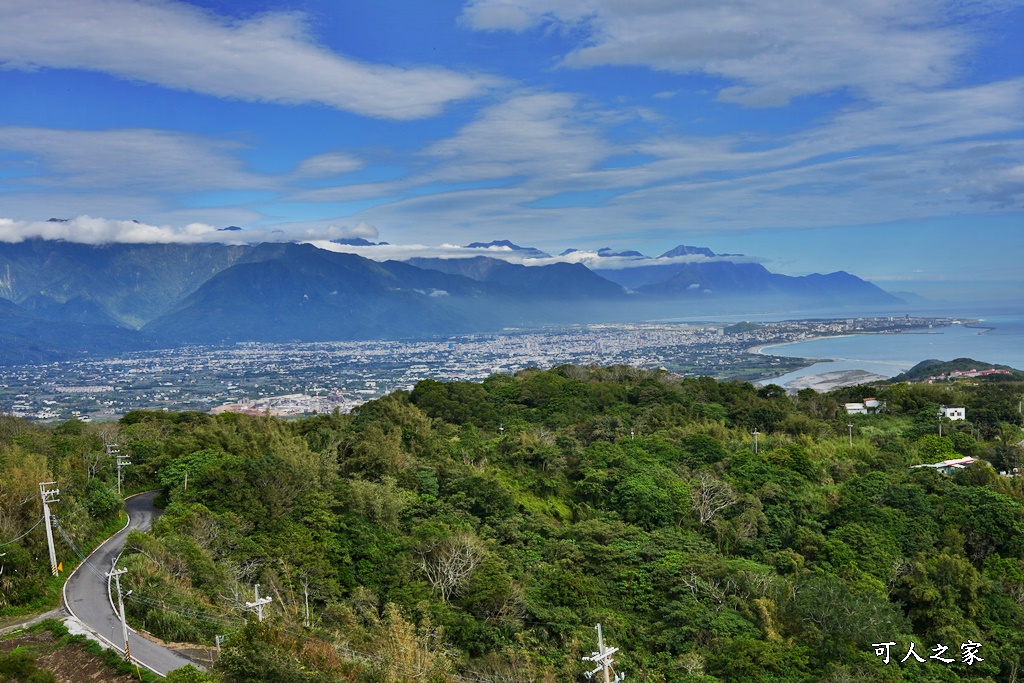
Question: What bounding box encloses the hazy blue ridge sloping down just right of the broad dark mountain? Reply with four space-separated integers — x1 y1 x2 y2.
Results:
406 256 625 299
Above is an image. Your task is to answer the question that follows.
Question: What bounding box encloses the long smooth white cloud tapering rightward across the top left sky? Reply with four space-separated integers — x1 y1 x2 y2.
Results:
0 0 494 120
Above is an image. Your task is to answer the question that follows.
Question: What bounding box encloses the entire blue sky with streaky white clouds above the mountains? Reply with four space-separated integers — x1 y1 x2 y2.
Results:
0 0 1024 299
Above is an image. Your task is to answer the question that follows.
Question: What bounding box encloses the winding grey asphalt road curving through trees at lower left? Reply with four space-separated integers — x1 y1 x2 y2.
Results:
63 490 193 676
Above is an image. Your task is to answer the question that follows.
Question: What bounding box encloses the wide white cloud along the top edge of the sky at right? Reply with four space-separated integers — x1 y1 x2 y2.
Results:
463 0 1005 105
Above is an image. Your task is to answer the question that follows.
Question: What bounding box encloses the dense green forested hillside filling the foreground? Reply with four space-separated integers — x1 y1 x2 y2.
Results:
0 367 1024 683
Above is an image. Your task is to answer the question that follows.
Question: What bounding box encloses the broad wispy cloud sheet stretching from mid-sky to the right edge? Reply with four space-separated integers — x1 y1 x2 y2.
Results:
323 79 1024 245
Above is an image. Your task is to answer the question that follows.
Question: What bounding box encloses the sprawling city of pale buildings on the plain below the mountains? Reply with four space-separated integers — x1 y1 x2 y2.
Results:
0 317 951 421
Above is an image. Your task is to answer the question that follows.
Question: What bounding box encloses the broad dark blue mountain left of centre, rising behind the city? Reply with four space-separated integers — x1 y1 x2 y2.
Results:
143 244 516 343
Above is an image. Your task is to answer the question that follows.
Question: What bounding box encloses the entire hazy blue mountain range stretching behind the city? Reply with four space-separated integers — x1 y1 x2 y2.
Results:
0 240 901 364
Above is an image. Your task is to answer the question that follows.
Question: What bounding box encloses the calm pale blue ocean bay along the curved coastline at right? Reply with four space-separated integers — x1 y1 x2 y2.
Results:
762 309 1024 386
